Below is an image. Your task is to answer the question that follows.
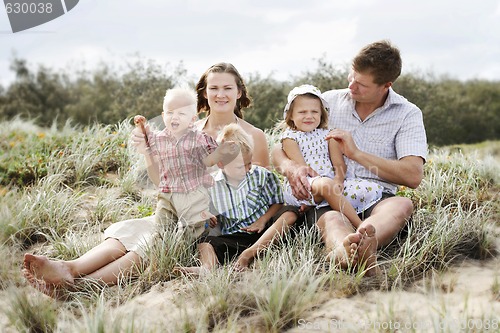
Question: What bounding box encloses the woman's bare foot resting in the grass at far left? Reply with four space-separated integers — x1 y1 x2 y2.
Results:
24 253 74 286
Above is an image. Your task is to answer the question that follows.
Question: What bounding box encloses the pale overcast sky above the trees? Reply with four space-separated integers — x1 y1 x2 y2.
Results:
0 0 500 87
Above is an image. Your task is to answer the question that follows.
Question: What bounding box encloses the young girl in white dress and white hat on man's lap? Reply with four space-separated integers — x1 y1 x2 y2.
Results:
237 85 383 268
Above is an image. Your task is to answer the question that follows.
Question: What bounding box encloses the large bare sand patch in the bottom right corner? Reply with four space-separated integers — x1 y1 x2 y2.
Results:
288 257 500 332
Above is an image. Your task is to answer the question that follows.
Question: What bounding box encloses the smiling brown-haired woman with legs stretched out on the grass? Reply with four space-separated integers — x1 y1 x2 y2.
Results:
23 63 269 297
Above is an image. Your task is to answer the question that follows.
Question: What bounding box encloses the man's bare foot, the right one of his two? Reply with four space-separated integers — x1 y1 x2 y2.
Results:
357 224 380 276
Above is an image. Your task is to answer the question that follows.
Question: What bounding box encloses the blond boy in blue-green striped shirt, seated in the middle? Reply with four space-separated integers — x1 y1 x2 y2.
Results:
177 124 283 274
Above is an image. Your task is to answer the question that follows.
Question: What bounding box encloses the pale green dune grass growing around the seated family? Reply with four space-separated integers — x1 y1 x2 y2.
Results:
0 119 500 332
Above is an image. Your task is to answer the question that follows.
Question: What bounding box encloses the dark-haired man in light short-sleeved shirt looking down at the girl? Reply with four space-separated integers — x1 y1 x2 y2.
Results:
273 41 427 275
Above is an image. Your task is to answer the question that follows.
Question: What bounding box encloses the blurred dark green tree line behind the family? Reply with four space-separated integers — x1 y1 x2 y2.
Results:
0 58 500 146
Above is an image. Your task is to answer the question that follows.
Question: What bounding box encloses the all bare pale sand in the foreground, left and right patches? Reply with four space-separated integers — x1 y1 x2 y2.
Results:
0 233 500 333
